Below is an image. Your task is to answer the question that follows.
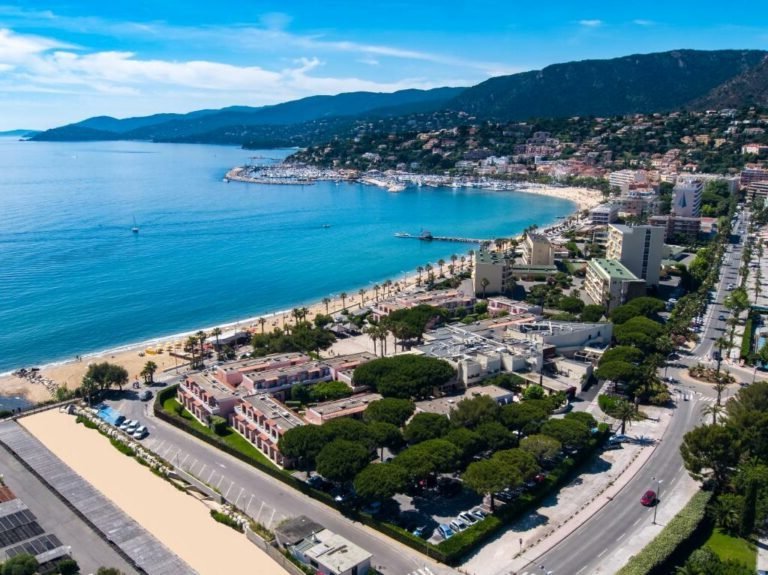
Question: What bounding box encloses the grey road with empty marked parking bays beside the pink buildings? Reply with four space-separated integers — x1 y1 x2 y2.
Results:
110 394 455 575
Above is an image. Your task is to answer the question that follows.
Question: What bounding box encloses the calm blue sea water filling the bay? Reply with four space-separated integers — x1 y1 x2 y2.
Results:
0 139 574 372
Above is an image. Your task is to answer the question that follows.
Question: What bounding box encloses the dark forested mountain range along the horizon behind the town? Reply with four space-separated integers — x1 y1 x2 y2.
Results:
33 50 768 147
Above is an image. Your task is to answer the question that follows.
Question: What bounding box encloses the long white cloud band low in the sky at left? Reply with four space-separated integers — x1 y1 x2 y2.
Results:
0 26 462 111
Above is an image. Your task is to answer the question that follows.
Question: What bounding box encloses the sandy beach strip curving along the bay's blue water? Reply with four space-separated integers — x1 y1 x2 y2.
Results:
0 182 603 403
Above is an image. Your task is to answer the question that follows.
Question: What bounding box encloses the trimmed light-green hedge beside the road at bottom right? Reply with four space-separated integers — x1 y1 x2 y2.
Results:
617 491 712 575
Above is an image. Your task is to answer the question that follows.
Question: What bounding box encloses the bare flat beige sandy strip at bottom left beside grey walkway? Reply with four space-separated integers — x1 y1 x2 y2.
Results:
24 410 286 575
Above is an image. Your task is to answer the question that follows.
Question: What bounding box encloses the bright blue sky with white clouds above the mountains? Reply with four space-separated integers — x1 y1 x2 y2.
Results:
0 0 768 130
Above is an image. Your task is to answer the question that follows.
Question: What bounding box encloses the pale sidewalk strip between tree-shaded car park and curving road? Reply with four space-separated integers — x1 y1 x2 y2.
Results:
461 407 671 575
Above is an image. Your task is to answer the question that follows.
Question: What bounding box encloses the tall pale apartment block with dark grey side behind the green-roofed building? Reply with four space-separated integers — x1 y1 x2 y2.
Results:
605 224 665 286
